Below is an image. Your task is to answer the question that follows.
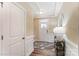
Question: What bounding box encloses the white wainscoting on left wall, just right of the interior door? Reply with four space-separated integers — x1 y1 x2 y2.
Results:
25 35 34 56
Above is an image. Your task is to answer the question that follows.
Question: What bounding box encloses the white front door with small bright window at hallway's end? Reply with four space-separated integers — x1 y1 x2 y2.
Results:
39 19 49 42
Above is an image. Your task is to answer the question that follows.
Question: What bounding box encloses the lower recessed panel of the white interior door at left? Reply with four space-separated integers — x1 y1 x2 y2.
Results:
10 40 24 56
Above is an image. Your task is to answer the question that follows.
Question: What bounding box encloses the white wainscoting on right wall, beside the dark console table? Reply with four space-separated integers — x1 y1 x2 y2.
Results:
64 35 78 56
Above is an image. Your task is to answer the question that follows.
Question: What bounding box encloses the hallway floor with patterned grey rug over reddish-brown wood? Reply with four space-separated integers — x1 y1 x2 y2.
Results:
31 41 56 56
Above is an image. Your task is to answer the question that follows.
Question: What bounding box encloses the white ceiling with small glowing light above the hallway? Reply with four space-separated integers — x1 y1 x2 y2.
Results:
28 2 63 17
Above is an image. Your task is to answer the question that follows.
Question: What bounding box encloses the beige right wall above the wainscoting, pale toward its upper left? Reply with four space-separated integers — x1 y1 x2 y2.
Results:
61 3 79 44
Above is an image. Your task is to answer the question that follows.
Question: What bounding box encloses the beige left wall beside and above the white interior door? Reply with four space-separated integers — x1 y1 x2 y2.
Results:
18 2 34 35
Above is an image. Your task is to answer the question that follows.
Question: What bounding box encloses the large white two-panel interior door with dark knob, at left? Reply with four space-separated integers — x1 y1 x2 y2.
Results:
2 3 25 56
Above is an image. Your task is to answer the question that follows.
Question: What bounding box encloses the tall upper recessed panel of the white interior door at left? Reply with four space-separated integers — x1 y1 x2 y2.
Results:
10 5 24 37
